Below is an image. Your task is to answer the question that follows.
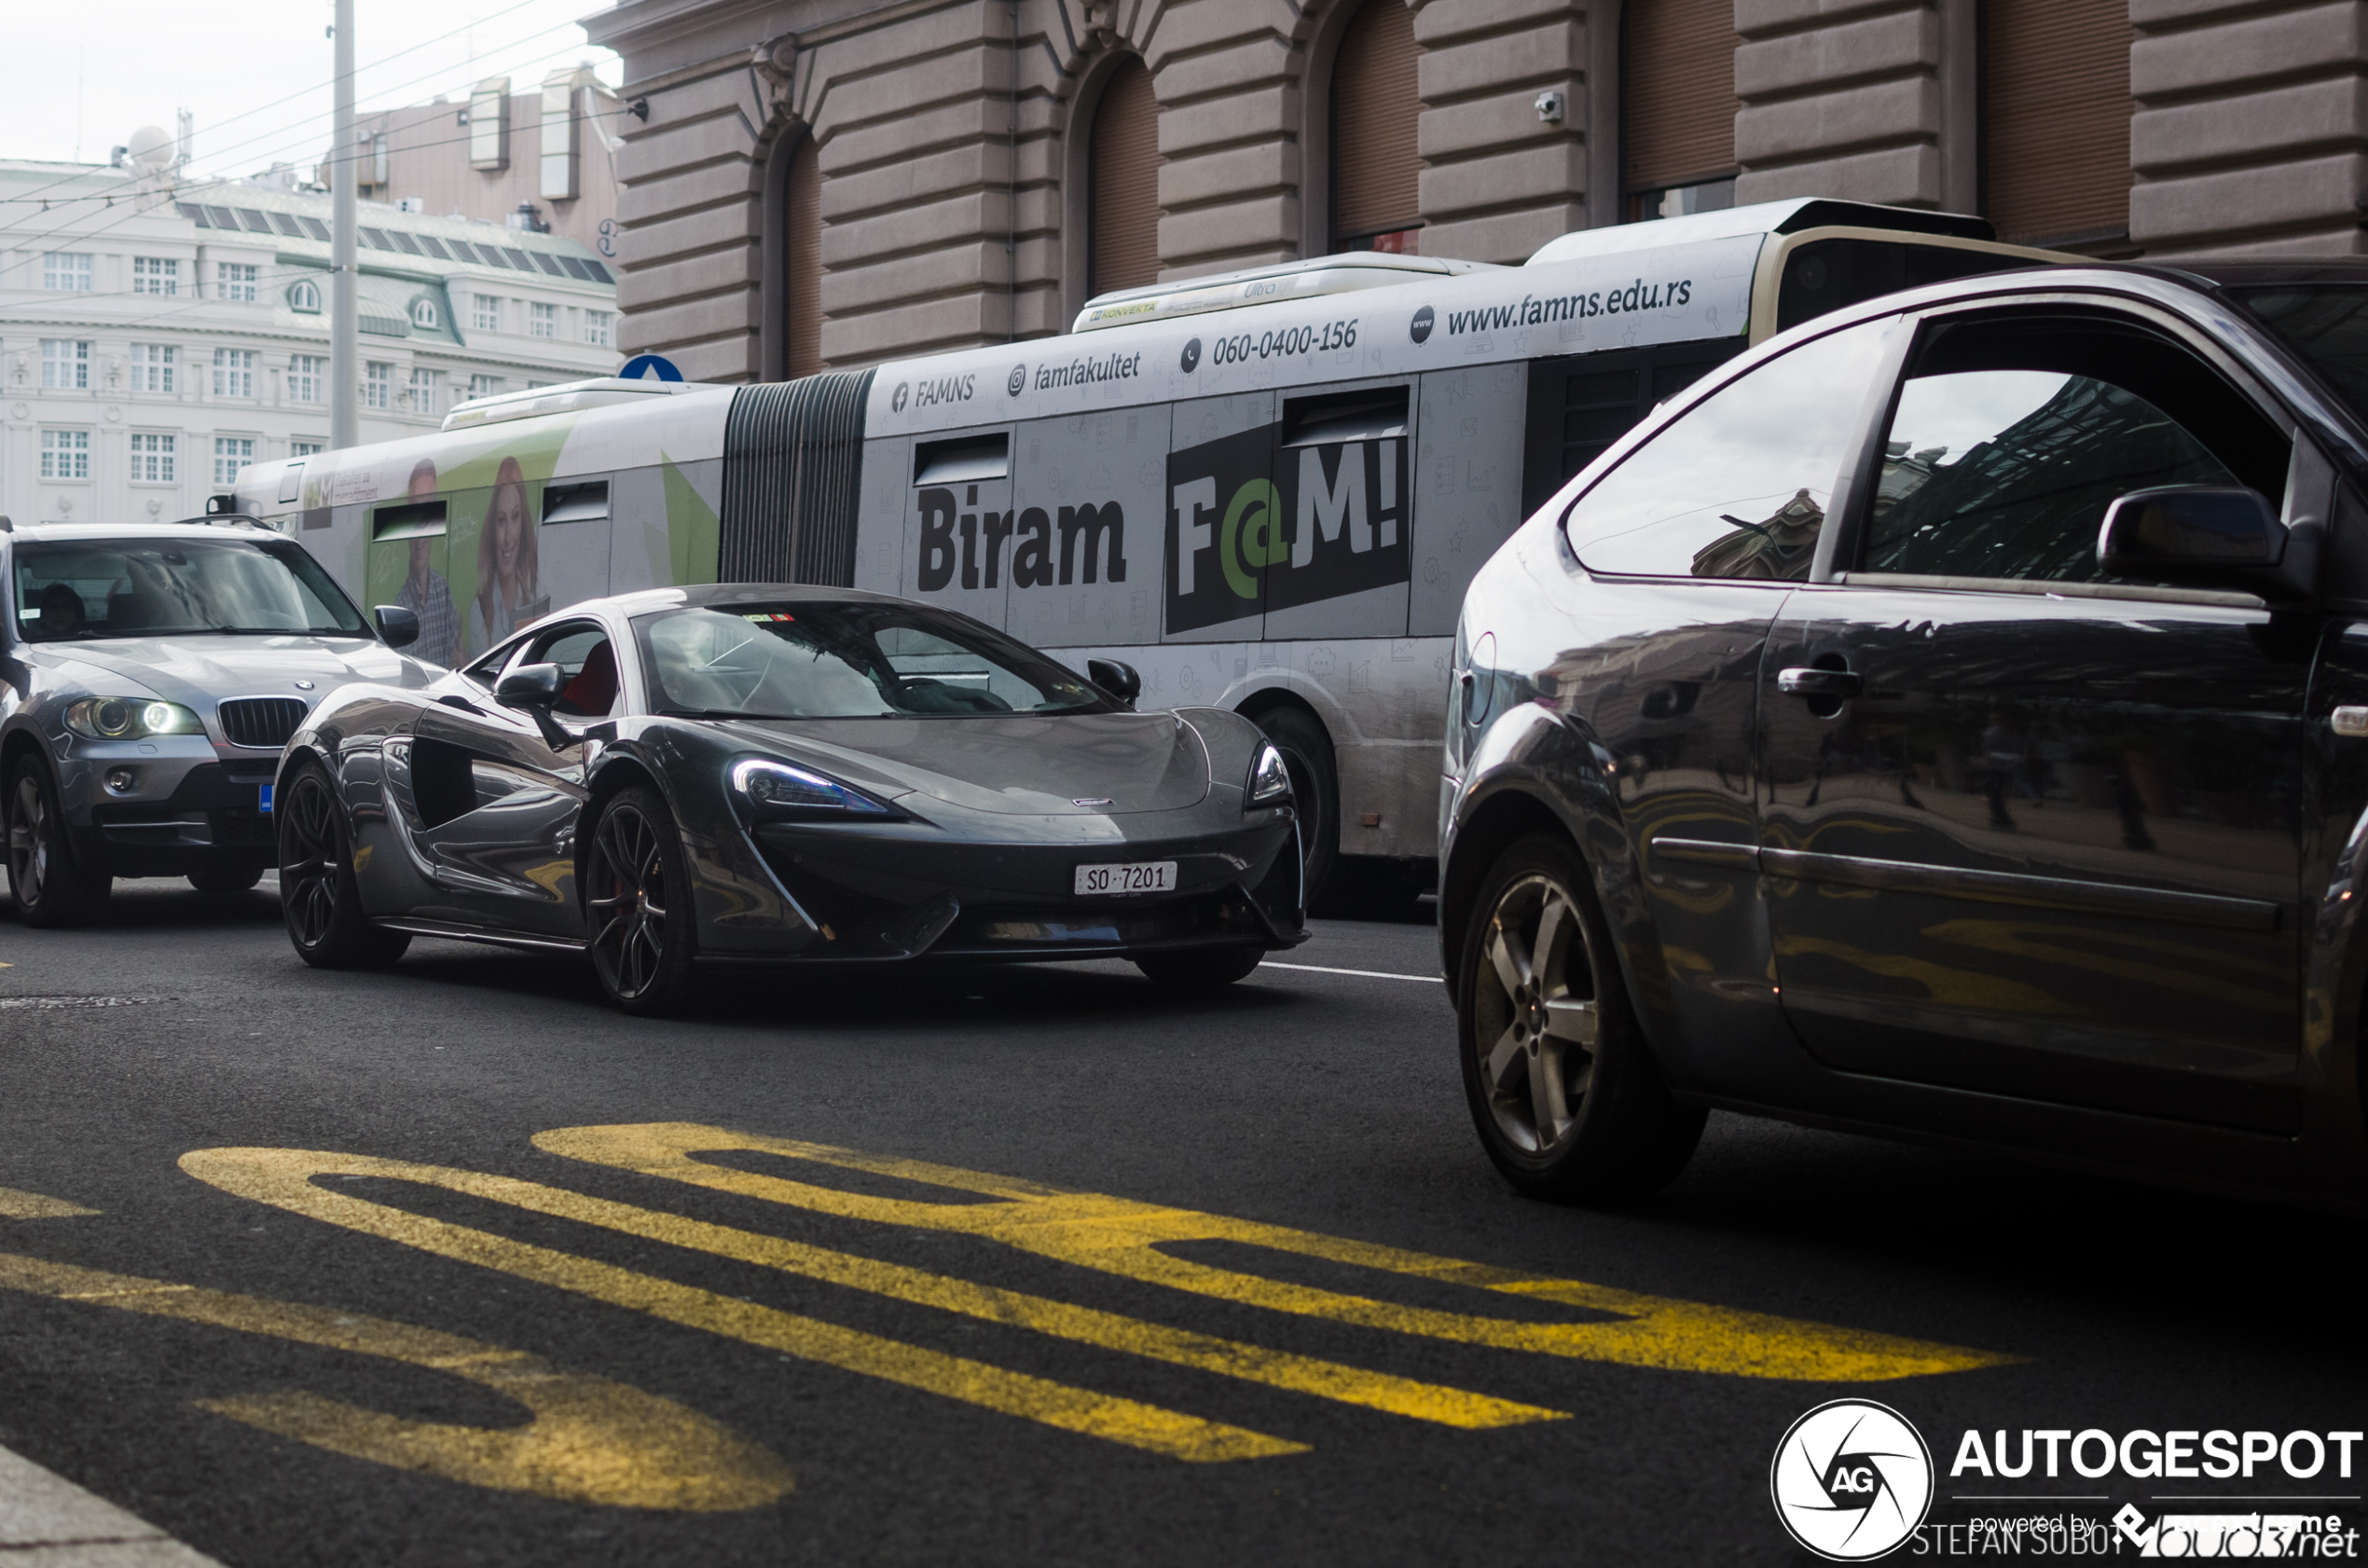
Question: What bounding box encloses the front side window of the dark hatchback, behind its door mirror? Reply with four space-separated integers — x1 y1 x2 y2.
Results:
1864 317 2285 583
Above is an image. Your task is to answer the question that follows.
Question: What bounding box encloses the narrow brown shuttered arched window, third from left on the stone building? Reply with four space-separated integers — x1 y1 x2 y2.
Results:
1330 0 1424 254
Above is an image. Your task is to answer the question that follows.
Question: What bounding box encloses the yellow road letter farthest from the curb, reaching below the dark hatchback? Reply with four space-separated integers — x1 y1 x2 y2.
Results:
542 1122 2020 1383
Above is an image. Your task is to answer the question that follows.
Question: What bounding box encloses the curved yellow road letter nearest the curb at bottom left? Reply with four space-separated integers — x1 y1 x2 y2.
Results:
0 1253 793 1514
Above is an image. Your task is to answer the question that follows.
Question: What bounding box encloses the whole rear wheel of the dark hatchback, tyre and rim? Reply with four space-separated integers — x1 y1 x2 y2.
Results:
1456 836 1705 1204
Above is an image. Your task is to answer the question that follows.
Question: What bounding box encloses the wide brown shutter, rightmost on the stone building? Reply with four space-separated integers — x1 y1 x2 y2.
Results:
1982 0 2134 240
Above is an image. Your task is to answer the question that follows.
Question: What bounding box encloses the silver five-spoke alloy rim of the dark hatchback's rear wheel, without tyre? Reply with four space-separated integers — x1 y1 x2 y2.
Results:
1473 874 1601 1156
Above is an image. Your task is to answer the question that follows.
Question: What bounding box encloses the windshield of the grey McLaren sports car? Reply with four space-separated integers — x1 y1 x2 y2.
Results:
632 601 1115 718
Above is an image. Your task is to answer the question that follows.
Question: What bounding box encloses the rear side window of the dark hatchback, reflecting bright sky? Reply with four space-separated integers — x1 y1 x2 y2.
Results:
1563 317 1892 580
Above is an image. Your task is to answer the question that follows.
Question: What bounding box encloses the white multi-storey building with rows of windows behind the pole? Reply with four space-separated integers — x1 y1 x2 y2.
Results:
0 158 620 524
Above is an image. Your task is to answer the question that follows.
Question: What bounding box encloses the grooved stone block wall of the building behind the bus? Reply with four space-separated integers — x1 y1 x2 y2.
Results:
589 0 2368 381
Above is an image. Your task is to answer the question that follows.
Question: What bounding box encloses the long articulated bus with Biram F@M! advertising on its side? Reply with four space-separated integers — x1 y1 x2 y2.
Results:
234 201 2067 895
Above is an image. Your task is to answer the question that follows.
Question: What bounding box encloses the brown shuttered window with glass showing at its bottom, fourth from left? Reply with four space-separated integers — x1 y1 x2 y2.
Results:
1619 0 1742 220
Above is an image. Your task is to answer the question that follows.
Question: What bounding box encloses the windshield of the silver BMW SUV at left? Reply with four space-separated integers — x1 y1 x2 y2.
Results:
12 538 372 642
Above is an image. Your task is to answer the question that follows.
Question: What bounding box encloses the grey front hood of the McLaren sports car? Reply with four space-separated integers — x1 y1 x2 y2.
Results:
729 713 1207 818
